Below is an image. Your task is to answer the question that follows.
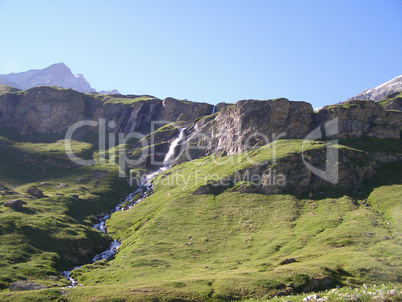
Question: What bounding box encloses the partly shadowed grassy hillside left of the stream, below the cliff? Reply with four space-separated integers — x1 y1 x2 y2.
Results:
0 128 129 289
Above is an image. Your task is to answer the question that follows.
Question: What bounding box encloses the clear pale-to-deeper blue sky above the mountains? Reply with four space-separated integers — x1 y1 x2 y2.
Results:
0 0 402 107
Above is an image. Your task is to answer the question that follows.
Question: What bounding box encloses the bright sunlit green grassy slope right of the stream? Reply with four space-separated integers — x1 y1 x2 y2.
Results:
34 139 402 301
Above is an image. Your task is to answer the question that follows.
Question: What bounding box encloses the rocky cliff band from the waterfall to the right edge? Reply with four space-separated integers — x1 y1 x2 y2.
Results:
177 99 402 163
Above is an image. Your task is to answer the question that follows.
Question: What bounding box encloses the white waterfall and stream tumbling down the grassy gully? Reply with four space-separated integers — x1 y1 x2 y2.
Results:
61 128 187 287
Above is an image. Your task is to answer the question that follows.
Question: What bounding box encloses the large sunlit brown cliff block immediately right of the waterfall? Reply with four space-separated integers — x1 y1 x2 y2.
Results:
179 99 313 162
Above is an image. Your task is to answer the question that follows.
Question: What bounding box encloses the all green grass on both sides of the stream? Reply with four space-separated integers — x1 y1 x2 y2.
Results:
0 126 402 301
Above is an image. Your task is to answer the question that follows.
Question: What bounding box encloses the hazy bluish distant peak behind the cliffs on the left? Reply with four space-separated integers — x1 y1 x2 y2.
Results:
0 63 103 93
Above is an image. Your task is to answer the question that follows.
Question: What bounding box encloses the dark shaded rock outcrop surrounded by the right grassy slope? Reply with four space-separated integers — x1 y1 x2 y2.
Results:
193 143 377 195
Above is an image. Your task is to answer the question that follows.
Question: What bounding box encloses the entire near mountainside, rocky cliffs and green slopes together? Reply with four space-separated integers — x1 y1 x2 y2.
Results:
0 79 402 301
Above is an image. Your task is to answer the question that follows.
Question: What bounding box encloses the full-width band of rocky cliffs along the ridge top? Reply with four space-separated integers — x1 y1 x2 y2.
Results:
0 87 402 170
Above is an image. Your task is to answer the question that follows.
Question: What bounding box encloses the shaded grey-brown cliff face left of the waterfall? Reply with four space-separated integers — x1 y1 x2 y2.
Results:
0 87 213 134
